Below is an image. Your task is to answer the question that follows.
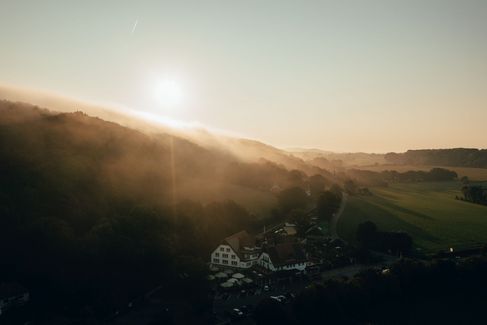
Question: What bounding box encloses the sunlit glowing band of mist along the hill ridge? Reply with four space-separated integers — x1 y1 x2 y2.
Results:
0 86 325 174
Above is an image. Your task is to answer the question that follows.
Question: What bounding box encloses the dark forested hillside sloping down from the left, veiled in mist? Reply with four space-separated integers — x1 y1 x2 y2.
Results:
0 101 331 323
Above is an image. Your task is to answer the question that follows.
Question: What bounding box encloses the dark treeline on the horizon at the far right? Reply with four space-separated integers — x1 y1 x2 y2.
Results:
385 148 487 168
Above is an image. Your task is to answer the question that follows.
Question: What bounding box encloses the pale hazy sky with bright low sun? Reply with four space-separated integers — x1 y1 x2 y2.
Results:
0 0 487 152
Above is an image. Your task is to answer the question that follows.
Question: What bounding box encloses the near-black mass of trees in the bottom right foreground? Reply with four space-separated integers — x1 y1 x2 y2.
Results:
255 257 487 324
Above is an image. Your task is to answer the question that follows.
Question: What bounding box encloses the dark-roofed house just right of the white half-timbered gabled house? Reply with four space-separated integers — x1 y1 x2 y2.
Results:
258 242 307 271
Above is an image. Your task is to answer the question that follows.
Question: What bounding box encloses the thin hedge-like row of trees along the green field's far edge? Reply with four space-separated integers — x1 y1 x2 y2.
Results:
348 168 458 186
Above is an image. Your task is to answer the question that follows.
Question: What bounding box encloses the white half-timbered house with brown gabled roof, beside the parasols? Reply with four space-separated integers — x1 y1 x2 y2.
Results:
211 230 262 269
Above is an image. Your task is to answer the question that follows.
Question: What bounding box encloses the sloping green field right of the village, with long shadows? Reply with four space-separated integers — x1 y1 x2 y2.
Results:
338 182 487 253
